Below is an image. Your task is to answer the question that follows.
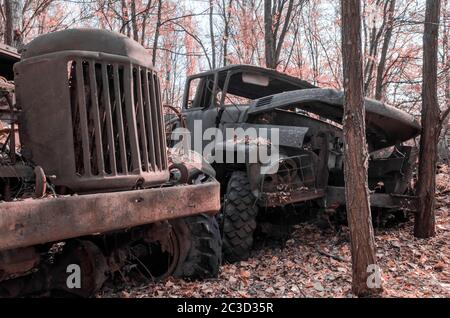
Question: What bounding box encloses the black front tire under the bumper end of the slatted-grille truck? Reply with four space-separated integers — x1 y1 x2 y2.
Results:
175 214 222 279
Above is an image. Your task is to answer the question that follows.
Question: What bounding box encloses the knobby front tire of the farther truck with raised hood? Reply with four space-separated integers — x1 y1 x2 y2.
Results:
221 171 258 263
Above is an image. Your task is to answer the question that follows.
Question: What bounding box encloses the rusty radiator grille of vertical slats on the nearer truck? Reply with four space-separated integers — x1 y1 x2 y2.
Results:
68 59 167 177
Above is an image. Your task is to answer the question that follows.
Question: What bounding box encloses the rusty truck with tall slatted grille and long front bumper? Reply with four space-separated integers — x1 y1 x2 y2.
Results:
0 29 221 297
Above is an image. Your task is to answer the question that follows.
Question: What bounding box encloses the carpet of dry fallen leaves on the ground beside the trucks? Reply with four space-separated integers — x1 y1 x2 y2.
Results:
98 175 450 298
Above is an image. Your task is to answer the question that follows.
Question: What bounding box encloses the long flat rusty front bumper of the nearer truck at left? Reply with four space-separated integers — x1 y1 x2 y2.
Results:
0 181 220 250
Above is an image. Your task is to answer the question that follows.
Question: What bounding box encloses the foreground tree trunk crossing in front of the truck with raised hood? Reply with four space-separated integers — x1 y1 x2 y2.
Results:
341 0 381 296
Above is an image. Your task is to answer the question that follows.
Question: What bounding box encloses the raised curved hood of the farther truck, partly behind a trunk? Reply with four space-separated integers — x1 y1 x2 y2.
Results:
247 88 420 150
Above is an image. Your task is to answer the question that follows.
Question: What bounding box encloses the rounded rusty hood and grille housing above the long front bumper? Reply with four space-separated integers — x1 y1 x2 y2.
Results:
15 29 169 193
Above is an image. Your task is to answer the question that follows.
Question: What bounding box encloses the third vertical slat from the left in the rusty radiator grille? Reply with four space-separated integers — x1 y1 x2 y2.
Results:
102 63 117 175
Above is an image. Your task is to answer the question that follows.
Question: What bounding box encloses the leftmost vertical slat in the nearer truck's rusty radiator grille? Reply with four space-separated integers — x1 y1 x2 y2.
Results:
75 60 92 176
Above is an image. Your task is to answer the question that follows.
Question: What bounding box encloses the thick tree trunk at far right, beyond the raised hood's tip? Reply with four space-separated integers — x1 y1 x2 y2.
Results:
414 0 441 238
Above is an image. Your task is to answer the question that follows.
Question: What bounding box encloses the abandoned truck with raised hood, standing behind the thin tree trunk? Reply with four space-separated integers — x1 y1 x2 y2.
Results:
178 65 420 262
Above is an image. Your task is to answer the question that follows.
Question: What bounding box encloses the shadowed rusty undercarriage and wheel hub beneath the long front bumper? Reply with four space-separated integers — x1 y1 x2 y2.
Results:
0 218 197 298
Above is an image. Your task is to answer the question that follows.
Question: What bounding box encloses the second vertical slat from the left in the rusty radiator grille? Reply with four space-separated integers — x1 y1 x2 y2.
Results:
89 62 105 175
